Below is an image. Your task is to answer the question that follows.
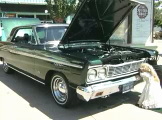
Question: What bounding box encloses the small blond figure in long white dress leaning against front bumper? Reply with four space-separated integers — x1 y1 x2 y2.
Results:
138 63 162 109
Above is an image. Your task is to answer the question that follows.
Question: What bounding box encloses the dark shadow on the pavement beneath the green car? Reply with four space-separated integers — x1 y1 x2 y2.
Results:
0 65 146 120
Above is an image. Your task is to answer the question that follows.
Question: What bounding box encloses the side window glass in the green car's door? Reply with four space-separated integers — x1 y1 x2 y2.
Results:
12 28 36 44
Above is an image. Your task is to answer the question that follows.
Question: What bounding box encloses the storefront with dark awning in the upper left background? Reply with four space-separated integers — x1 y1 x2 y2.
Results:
0 0 50 22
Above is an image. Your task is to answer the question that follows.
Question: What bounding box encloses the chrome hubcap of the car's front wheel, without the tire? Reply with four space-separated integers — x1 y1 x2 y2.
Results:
52 76 68 103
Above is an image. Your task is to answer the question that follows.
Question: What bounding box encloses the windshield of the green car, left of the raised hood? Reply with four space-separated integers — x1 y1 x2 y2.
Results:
36 26 67 44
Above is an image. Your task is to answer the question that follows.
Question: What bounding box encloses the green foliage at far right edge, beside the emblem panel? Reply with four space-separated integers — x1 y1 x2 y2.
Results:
154 2 162 27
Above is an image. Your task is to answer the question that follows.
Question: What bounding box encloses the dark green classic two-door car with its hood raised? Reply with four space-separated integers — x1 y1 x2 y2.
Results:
0 0 158 107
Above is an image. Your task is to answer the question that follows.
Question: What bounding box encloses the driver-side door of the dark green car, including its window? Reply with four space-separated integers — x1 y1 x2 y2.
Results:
10 27 37 75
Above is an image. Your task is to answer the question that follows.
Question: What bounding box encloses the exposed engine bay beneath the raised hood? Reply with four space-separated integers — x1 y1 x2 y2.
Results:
63 44 150 64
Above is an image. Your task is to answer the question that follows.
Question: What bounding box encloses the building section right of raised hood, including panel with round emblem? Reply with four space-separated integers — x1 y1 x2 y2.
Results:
112 0 156 49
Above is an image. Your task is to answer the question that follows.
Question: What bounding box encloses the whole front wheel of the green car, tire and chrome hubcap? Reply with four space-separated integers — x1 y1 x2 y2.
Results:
51 73 77 107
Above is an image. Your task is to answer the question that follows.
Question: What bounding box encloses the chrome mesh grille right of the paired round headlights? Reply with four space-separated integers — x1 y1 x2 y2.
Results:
108 60 144 77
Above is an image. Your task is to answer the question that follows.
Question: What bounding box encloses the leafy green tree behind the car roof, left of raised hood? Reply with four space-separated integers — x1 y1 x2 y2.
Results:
46 0 80 22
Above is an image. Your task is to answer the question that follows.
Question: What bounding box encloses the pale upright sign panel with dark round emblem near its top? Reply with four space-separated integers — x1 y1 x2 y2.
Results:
132 0 154 46
